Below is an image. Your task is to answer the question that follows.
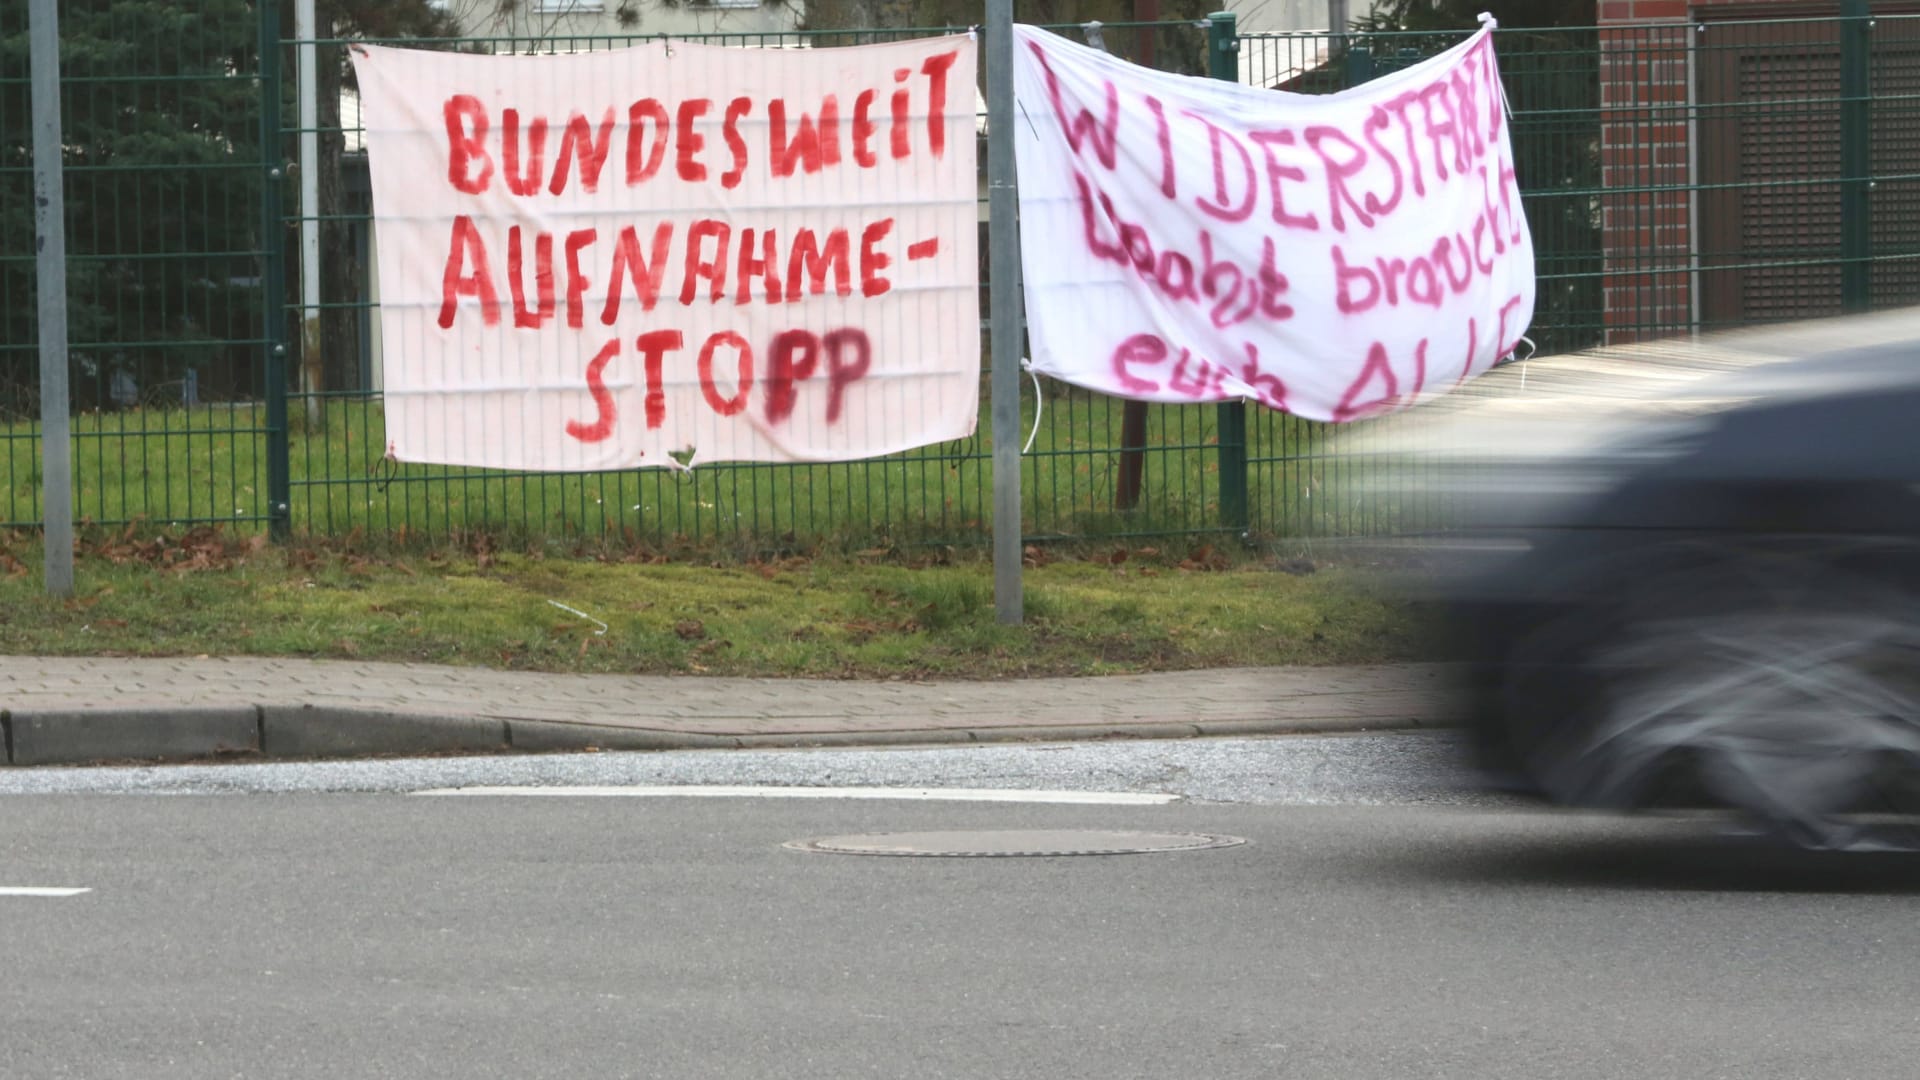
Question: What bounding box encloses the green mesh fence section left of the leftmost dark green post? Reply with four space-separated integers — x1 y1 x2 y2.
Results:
0 0 269 527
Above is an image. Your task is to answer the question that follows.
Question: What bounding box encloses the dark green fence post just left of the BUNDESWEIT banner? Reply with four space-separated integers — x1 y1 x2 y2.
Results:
259 4 294 540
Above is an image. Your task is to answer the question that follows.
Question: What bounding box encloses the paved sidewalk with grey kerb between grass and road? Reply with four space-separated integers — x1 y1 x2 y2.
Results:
0 645 1452 765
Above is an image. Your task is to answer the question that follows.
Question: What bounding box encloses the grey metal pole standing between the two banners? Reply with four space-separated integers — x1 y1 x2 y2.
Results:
987 0 1025 623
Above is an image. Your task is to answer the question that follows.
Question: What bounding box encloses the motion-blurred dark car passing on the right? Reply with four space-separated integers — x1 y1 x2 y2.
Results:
1407 309 1920 851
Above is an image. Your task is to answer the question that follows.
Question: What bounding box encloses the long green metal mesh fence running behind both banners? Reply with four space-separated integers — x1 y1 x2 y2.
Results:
0 14 1920 548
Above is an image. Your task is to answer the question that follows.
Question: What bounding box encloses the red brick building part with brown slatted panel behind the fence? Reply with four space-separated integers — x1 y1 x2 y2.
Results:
1599 0 1920 342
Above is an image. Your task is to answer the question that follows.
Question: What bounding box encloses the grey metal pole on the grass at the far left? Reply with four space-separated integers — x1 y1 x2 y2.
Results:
27 0 73 596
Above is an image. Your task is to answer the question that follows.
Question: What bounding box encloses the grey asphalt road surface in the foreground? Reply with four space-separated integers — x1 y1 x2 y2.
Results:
0 726 1920 1080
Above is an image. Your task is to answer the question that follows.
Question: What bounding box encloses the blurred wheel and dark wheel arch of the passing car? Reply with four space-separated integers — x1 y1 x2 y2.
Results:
1503 538 1920 851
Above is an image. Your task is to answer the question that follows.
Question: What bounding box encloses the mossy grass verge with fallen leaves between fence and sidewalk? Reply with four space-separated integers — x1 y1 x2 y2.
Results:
0 528 1432 678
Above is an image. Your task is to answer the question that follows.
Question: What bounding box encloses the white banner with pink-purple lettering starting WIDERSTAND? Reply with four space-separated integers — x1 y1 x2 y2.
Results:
1014 27 1534 421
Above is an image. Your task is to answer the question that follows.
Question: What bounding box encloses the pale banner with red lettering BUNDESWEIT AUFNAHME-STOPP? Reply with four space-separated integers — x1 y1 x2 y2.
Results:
353 35 979 471
